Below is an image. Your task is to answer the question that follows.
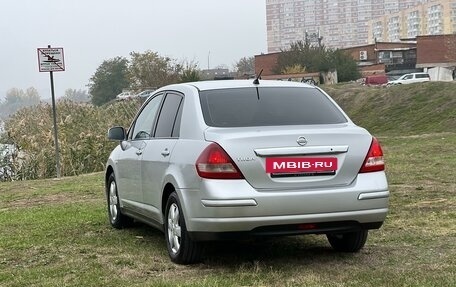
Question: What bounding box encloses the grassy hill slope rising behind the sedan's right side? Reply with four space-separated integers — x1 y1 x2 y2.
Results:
323 82 456 135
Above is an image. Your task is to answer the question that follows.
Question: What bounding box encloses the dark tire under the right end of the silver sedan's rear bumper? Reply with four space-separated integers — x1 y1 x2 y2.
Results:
326 229 369 252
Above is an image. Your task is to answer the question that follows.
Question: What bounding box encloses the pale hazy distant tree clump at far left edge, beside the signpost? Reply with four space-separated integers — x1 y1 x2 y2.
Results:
0 87 40 119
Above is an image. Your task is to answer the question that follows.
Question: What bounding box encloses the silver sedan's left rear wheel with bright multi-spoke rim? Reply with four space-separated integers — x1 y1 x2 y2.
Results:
164 192 201 264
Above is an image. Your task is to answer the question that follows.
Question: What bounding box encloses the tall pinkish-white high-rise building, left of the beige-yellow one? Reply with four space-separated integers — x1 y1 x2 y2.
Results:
266 0 433 53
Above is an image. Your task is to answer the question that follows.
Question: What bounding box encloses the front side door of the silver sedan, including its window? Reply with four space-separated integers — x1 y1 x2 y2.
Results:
117 94 164 212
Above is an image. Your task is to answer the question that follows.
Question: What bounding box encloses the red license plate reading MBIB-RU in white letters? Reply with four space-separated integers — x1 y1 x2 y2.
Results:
266 157 337 173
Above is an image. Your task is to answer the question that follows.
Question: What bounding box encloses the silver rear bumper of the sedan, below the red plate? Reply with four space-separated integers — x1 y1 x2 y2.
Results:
178 172 389 234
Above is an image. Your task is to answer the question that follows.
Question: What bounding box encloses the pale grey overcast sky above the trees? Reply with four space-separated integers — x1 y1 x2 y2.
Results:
0 0 267 99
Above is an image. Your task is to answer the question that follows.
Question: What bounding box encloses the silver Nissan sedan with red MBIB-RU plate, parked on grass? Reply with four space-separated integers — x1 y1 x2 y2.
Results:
105 79 389 264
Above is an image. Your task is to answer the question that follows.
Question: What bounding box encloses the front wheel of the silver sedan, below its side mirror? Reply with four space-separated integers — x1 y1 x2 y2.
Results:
106 173 133 229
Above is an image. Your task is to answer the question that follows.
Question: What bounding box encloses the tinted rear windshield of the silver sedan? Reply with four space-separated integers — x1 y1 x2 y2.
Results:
200 87 347 127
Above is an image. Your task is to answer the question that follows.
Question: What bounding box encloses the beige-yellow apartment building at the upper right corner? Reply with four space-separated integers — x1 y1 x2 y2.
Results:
368 0 456 43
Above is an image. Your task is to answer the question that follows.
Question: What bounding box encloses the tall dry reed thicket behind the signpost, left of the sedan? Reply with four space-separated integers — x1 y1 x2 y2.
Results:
5 100 140 180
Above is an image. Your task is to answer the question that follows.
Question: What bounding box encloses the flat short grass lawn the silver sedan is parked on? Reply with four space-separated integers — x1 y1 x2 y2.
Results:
0 82 456 287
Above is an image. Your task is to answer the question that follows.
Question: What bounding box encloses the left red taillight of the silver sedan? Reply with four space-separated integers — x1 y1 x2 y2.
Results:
196 143 244 179
